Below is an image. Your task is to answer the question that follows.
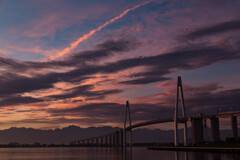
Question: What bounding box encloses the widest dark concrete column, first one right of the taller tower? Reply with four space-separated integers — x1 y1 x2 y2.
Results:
191 118 203 145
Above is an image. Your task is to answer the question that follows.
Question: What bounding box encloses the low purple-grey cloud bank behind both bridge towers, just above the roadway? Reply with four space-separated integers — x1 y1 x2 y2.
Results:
47 83 240 125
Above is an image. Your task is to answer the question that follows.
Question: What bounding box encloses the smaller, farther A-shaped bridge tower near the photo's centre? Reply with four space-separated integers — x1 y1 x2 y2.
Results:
123 101 132 147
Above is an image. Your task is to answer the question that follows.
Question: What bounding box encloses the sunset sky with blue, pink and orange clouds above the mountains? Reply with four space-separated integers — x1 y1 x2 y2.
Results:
0 0 240 129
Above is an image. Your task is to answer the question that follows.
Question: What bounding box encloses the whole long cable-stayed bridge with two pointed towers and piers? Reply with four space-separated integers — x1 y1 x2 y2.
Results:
71 77 240 147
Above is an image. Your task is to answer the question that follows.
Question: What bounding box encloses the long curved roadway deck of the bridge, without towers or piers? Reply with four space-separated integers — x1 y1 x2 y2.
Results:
71 111 240 144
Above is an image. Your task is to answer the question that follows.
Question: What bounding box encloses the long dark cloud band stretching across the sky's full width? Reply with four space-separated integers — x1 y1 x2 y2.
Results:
0 43 240 102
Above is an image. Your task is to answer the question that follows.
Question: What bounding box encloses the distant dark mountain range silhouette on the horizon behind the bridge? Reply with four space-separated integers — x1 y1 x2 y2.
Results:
0 126 236 144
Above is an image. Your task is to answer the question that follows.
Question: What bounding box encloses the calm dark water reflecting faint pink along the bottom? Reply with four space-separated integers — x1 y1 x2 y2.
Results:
0 147 240 160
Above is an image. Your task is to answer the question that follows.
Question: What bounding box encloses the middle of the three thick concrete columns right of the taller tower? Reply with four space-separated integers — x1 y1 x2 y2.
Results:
210 117 220 142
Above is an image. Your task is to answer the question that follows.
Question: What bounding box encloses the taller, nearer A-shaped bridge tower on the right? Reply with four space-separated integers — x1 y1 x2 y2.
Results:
174 76 187 146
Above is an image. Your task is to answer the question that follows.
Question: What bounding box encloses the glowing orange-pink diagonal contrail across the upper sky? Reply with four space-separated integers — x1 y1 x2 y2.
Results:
51 0 153 59
